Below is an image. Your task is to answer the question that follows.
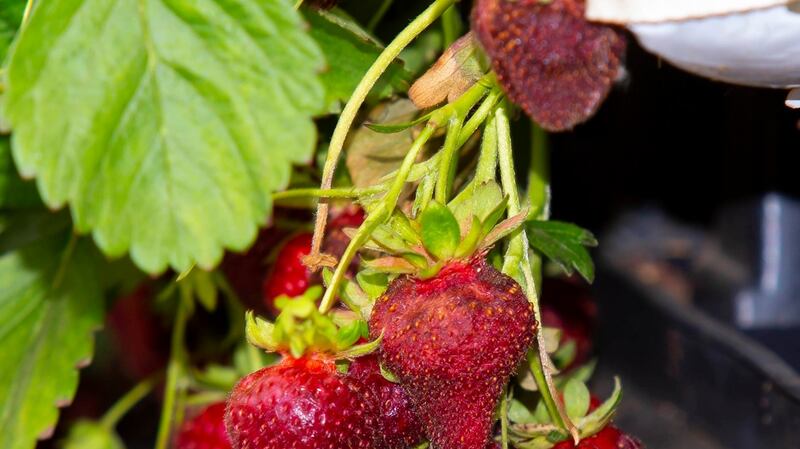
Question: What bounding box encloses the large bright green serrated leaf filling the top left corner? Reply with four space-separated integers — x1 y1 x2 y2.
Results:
4 0 324 273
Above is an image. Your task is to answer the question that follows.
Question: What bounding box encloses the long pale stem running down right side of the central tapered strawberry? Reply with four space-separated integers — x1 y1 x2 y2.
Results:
495 107 579 442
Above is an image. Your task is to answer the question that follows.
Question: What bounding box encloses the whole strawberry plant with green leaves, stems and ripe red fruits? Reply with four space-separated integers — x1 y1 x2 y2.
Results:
0 0 639 449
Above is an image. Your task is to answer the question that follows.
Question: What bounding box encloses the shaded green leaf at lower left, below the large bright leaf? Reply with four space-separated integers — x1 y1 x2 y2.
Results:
0 228 103 449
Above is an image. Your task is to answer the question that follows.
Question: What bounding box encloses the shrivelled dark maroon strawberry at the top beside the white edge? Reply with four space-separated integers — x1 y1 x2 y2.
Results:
472 0 625 131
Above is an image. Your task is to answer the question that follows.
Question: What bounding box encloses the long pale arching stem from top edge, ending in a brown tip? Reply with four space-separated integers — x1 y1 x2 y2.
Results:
309 0 457 268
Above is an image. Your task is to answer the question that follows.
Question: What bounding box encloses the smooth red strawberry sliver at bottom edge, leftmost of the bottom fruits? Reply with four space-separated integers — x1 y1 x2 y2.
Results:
175 402 231 449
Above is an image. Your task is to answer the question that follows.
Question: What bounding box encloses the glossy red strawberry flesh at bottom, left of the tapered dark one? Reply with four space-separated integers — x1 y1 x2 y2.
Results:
225 356 375 449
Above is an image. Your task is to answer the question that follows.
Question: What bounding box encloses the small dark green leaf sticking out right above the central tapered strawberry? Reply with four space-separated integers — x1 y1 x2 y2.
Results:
527 220 597 282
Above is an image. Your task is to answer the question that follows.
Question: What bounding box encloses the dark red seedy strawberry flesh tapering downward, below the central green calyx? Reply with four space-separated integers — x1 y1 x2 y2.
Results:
370 257 536 449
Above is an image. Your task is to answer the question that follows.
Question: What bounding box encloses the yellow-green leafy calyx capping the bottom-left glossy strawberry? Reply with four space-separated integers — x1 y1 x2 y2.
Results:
245 286 381 359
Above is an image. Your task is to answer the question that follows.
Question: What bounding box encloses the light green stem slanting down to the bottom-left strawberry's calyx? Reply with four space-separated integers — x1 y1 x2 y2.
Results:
319 121 437 313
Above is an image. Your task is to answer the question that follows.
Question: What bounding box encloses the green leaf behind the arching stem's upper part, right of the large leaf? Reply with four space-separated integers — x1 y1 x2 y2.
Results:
304 8 411 113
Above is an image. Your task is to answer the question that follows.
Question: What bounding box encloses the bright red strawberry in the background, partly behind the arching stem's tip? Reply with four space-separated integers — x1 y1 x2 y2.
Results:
264 232 313 316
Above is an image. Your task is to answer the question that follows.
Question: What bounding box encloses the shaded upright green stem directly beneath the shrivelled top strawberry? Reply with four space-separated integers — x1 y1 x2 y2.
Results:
528 123 550 220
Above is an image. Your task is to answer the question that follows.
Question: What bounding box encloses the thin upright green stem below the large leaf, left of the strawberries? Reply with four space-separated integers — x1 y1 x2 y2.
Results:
155 295 191 449
